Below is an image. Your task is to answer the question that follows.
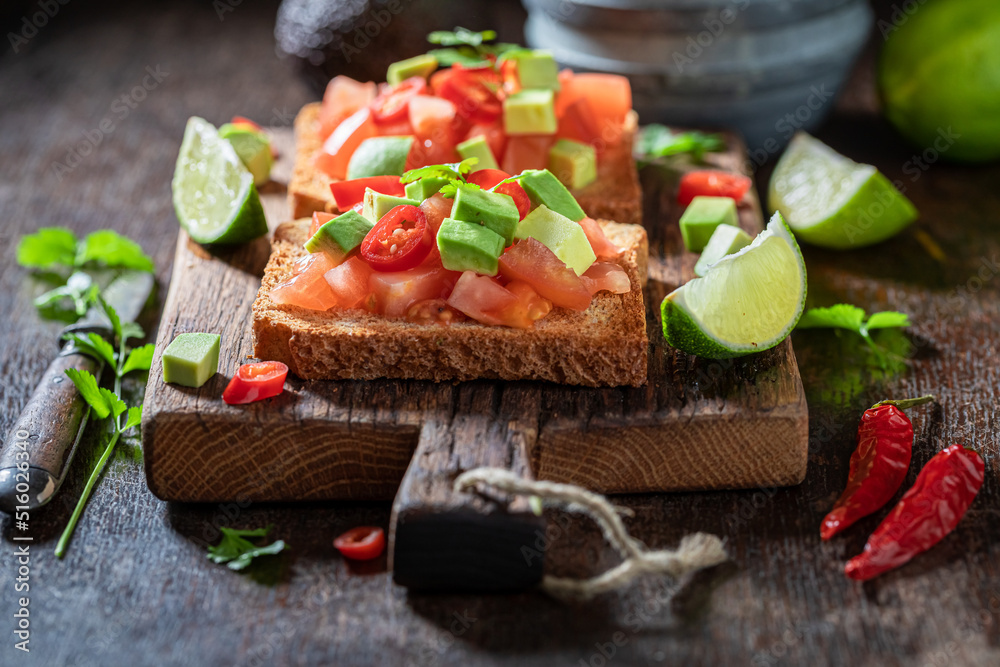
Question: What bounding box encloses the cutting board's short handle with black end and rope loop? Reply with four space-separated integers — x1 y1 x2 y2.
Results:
389 414 545 592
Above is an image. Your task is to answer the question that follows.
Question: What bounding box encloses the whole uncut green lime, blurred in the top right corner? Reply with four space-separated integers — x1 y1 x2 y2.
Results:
878 0 1000 162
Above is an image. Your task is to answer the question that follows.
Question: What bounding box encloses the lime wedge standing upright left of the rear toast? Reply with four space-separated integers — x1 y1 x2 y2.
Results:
172 116 267 244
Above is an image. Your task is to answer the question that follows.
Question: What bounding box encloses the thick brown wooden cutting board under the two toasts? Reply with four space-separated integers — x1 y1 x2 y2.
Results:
142 128 808 588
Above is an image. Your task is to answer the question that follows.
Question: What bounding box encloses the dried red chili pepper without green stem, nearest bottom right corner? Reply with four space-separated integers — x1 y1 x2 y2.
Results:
844 445 986 581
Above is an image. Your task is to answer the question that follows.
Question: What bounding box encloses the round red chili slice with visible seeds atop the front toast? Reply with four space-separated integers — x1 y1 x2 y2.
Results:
361 206 434 271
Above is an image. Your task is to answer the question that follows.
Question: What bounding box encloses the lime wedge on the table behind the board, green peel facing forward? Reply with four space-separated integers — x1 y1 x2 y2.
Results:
768 132 917 250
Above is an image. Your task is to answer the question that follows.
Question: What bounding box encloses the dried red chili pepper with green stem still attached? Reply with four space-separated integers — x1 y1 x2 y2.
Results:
819 395 934 540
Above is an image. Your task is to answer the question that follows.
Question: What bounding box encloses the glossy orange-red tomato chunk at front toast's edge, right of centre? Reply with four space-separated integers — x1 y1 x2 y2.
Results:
448 271 551 329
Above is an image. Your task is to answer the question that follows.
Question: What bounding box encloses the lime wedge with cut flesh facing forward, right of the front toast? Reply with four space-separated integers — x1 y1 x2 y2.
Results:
660 213 806 359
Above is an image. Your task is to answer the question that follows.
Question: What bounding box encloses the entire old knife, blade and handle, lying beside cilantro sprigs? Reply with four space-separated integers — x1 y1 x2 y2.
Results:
0 271 154 514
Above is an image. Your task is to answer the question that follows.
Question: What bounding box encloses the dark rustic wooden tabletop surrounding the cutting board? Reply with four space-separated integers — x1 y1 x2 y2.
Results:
0 3 1000 667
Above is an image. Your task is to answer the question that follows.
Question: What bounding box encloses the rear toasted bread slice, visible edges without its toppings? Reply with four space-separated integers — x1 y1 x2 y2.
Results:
288 102 642 224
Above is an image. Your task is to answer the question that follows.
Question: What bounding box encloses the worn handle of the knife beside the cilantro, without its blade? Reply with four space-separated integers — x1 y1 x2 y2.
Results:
0 344 101 514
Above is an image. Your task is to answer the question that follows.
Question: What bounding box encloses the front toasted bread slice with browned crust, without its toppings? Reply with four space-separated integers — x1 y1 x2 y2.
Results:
253 219 648 387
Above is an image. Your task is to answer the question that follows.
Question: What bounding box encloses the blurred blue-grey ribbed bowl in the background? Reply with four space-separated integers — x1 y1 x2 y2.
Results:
523 0 873 154
